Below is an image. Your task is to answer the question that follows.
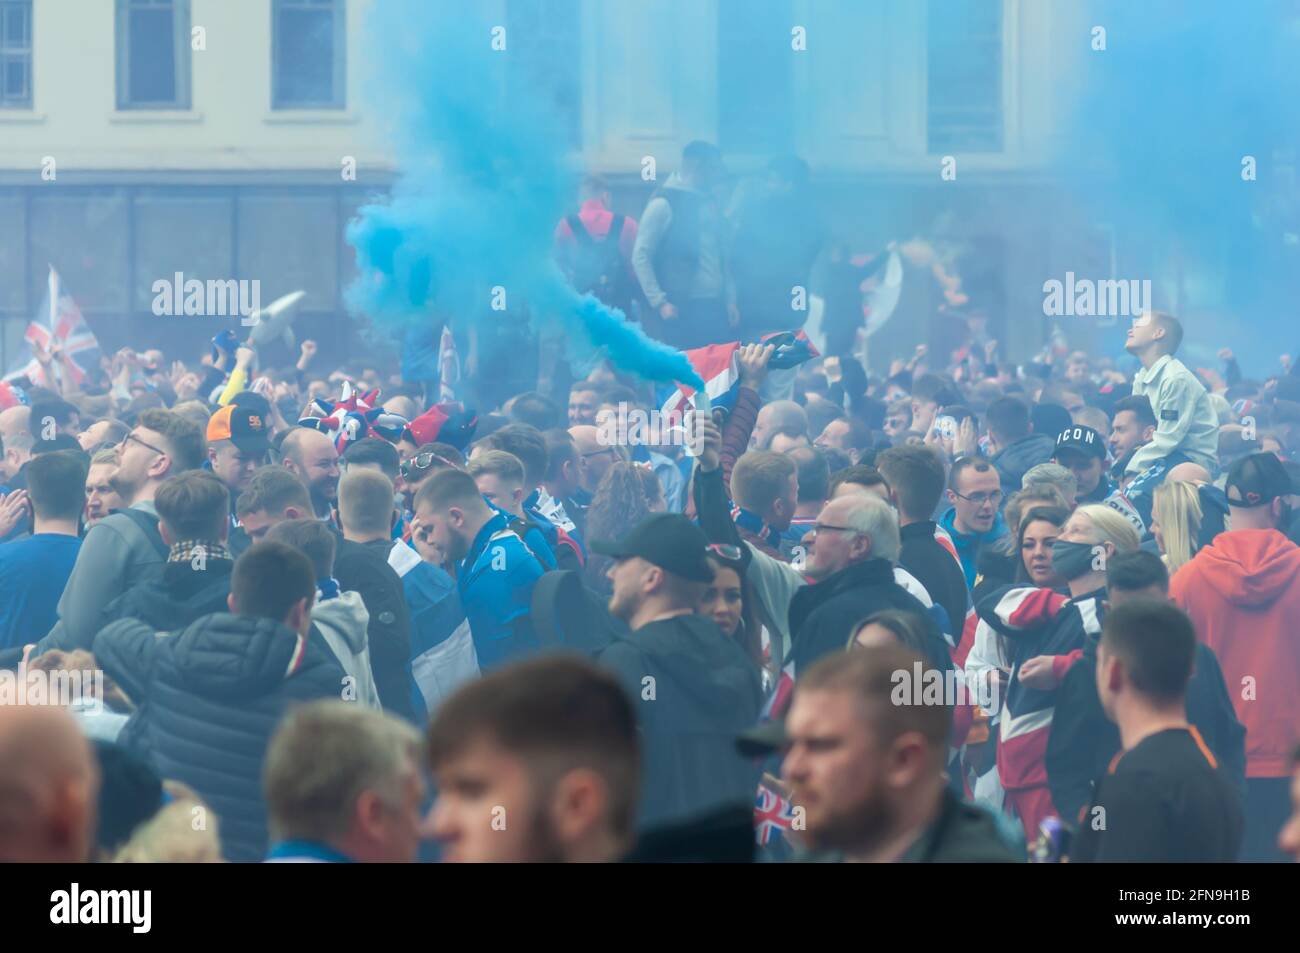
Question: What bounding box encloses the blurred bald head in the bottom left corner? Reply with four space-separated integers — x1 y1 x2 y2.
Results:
0 705 99 863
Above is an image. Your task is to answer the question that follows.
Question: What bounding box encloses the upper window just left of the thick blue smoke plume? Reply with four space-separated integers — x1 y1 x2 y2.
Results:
270 0 347 109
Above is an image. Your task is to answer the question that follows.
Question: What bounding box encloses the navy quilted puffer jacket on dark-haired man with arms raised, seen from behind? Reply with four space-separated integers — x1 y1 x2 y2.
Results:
94 612 343 861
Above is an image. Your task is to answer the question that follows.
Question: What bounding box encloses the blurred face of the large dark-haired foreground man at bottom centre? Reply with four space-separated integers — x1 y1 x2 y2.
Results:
429 736 563 863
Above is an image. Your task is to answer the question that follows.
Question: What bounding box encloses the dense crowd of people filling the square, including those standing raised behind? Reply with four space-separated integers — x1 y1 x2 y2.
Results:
0 143 1300 862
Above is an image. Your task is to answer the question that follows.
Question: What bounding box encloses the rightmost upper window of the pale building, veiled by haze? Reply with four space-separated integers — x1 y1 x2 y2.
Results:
926 0 1002 155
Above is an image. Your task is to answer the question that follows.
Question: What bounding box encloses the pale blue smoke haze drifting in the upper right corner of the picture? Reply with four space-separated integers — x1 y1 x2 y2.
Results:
1052 0 1300 371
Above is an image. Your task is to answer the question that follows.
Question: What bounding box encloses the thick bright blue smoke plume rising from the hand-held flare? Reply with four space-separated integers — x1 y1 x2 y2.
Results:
346 0 699 386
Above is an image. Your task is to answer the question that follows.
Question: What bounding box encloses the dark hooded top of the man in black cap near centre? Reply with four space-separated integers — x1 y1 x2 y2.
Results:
599 615 763 828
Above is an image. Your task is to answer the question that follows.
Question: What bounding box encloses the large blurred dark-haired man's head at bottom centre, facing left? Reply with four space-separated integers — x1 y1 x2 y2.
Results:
428 657 638 862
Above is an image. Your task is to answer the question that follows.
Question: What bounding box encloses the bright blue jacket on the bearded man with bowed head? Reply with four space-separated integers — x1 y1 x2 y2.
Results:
456 512 543 672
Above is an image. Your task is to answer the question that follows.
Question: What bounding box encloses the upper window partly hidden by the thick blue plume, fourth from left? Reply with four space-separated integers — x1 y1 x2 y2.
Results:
506 0 582 150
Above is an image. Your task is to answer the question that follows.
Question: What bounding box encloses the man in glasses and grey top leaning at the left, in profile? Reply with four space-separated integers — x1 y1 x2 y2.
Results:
17 408 204 664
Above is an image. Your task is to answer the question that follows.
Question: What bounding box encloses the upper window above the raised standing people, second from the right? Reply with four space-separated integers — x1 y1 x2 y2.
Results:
718 0 797 153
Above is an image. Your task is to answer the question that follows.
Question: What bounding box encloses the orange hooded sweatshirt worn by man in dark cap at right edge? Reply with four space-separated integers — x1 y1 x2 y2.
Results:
1169 529 1300 777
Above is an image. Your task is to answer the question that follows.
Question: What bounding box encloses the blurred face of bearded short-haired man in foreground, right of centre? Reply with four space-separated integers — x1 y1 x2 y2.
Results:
781 690 891 848
